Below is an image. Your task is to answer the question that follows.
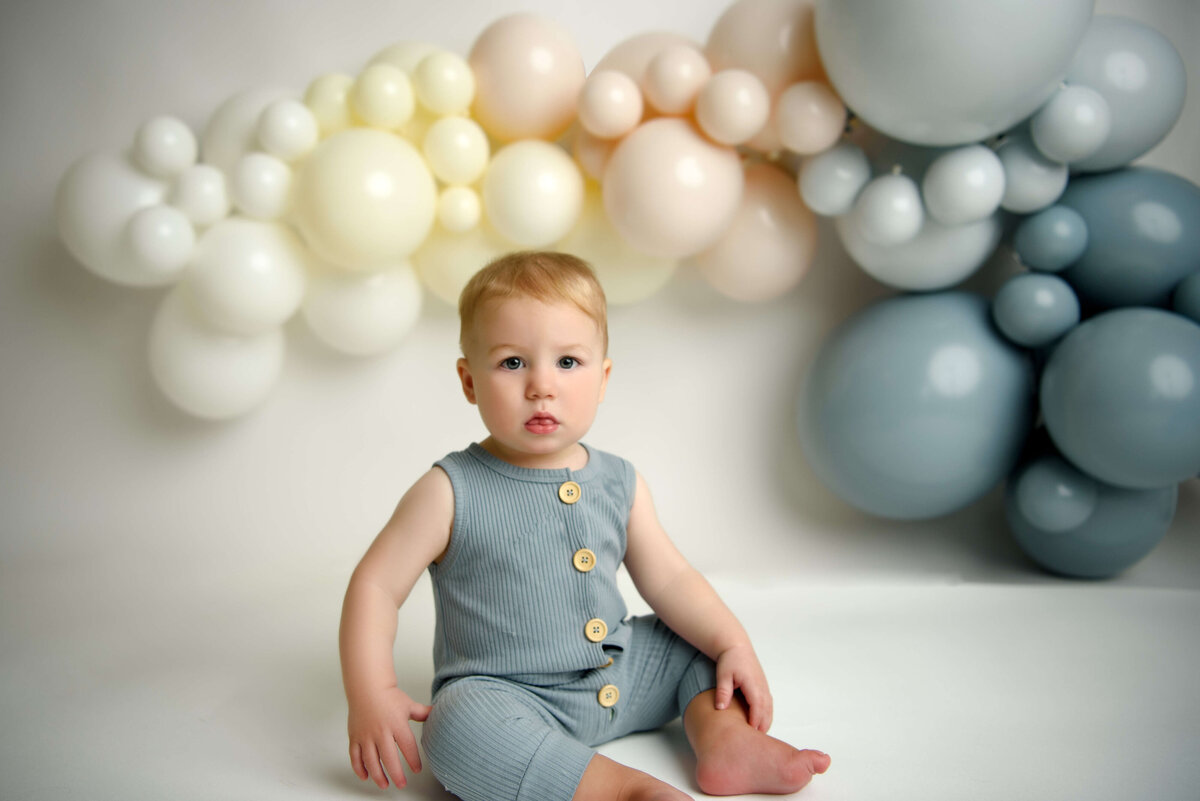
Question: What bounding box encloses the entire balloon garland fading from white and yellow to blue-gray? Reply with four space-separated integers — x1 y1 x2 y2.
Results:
56 0 1200 577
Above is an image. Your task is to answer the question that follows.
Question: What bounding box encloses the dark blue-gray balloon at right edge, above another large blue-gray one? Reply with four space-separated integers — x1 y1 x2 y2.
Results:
1060 167 1200 309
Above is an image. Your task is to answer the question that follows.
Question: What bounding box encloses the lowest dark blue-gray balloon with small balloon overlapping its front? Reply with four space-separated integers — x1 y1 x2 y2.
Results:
1004 456 1178 578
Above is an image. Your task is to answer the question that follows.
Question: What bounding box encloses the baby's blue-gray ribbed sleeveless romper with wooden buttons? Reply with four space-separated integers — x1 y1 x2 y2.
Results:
421 444 716 801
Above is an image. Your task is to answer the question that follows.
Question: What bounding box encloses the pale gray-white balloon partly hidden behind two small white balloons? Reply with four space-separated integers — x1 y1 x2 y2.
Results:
834 209 1003 291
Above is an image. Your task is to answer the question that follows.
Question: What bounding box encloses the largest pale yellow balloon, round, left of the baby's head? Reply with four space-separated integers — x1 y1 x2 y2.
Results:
294 128 437 270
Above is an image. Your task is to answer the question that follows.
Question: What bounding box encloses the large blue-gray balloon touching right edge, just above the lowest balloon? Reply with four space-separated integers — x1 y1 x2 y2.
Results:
1040 308 1200 489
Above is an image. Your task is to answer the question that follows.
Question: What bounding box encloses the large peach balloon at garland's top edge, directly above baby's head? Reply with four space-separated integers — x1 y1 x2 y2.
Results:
467 13 586 141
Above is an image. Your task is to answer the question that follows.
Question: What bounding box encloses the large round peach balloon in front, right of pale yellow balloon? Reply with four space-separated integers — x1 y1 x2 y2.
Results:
604 118 744 259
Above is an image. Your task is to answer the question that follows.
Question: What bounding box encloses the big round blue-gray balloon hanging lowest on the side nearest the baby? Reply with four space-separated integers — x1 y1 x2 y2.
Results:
798 293 1033 519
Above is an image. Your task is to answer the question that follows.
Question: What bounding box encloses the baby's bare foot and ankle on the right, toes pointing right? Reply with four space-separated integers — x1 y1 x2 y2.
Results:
683 689 829 795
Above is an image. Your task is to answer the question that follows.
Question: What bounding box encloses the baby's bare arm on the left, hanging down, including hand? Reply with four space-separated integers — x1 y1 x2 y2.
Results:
338 468 454 788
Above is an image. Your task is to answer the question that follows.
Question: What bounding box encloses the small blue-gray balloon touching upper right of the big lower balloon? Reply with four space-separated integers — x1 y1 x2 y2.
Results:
991 272 1079 348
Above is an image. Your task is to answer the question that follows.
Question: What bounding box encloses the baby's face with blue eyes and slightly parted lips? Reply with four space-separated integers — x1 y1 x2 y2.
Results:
458 297 612 468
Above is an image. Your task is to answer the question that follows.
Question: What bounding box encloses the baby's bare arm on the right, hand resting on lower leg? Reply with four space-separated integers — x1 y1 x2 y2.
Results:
625 474 773 731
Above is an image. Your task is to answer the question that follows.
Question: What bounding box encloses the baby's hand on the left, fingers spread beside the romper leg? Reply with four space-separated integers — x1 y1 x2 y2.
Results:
348 687 433 789
